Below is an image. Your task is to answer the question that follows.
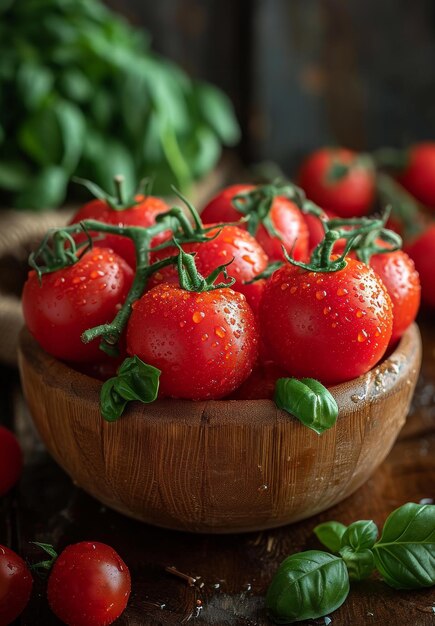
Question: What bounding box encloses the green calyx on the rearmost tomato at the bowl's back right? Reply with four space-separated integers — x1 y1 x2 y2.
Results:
232 181 303 239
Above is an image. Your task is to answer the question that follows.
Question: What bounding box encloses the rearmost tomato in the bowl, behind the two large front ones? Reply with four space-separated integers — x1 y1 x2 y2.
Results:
201 185 308 261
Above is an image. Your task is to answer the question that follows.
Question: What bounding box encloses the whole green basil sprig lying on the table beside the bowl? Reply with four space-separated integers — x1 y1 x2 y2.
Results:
266 503 435 624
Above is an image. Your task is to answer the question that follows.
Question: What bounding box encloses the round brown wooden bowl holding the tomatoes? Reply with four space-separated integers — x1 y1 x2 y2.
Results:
19 325 421 533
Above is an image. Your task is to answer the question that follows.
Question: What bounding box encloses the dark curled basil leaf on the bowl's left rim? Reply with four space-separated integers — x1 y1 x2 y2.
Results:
100 356 161 422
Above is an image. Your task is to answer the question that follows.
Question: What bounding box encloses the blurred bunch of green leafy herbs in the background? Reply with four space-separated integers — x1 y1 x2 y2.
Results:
0 0 239 209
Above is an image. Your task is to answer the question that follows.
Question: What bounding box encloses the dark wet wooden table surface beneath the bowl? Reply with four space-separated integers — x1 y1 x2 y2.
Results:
0 315 435 626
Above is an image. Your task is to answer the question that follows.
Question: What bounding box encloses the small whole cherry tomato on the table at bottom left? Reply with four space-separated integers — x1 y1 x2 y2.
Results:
47 541 131 626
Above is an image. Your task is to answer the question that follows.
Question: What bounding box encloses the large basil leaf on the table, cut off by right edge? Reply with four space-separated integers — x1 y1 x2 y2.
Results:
373 502 435 589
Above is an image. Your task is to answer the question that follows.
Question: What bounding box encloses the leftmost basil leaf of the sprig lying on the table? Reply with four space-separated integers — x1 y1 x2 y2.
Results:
266 550 349 624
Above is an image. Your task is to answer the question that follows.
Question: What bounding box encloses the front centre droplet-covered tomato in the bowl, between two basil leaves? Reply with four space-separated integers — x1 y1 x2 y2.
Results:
127 283 258 400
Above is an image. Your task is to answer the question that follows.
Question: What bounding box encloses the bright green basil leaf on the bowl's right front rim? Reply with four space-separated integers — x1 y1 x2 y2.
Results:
274 378 338 435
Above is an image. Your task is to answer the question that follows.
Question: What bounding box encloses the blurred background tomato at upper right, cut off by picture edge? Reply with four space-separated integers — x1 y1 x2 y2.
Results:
398 141 435 209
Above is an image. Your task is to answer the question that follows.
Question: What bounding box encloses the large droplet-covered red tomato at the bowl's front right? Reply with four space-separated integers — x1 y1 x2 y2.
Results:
260 258 393 385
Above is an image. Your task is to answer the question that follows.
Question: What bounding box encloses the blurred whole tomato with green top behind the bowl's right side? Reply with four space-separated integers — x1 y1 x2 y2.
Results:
298 148 375 217
